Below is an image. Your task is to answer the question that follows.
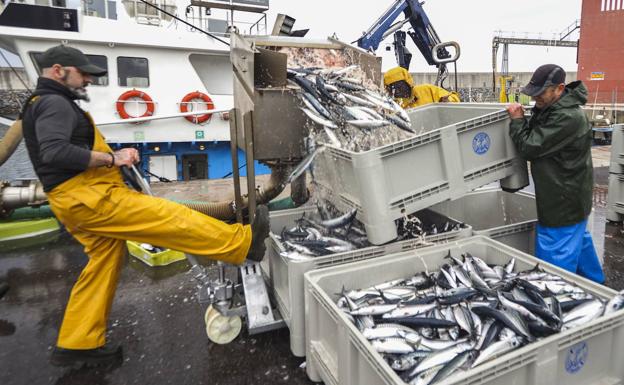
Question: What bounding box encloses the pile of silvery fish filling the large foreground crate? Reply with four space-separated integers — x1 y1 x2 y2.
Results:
337 253 624 385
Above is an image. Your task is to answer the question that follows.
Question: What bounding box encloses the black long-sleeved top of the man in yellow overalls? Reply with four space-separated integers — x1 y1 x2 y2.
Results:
22 78 94 192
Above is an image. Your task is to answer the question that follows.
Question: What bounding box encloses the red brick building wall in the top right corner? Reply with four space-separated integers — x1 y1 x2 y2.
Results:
578 0 624 103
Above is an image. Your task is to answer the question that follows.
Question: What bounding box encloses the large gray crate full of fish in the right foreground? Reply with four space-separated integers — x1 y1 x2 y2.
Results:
305 236 624 385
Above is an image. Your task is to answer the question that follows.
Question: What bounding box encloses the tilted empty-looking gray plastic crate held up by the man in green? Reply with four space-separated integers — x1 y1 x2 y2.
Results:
314 103 528 244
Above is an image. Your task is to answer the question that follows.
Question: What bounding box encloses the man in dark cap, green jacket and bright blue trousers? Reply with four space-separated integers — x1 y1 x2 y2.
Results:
507 64 605 283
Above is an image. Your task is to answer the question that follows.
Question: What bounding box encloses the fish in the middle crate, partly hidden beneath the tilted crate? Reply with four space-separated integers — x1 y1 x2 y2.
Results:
275 200 464 260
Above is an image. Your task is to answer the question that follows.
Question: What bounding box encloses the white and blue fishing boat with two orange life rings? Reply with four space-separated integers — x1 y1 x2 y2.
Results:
0 0 270 181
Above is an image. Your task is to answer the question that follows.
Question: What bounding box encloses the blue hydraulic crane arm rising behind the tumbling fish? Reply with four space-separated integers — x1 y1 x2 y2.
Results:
357 0 459 86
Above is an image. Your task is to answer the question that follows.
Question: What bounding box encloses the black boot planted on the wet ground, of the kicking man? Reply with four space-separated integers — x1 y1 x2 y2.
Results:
50 345 123 367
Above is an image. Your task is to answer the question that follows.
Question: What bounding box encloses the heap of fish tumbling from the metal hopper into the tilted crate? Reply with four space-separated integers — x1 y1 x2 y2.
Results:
288 65 415 152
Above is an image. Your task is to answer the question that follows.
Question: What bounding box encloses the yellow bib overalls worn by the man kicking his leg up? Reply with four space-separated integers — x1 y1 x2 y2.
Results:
48 115 251 349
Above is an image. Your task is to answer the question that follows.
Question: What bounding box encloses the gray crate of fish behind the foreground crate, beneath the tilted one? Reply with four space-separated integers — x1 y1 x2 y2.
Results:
265 202 472 357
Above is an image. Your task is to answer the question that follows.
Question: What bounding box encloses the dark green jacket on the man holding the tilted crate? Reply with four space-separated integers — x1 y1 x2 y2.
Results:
509 81 594 227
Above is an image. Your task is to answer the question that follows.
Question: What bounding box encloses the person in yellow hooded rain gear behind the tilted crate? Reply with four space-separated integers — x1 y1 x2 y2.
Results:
384 67 461 109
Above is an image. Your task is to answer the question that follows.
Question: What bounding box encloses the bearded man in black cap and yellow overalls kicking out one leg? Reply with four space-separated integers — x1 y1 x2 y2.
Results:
22 46 269 365
